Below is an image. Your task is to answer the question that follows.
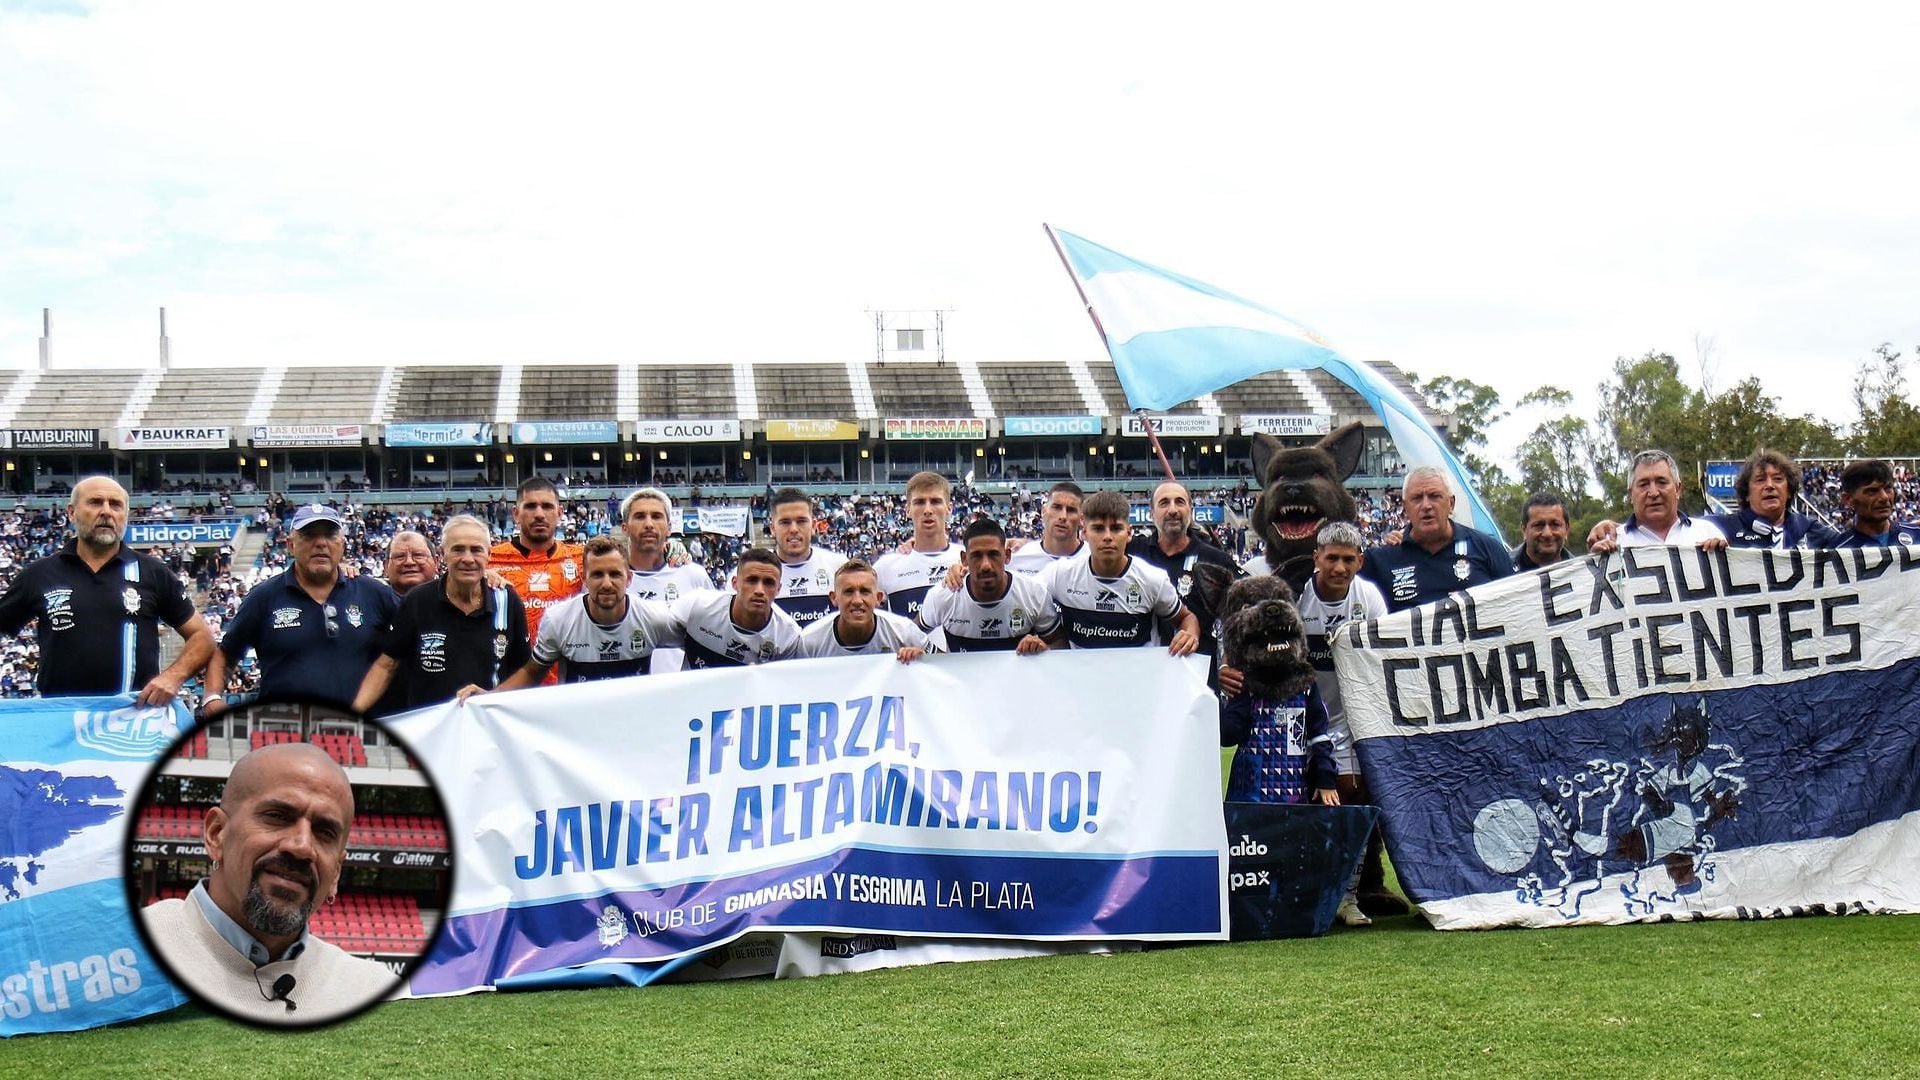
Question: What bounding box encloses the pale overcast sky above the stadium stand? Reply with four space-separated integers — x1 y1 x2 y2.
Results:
0 0 1920 463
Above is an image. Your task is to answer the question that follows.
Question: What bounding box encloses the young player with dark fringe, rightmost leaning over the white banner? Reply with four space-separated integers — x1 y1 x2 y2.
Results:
1035 492 1200 655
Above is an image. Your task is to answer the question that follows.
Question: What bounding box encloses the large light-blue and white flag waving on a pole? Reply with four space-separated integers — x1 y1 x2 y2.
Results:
1046 225 1500 536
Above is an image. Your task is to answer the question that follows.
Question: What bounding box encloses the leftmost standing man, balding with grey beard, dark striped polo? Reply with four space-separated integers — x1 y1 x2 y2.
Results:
0 477 213 705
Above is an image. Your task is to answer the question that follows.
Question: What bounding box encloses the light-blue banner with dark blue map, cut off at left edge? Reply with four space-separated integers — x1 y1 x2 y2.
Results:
0 694 192 1036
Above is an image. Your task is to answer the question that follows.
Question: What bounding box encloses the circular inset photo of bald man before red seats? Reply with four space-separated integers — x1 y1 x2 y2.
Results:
127 701 453 1028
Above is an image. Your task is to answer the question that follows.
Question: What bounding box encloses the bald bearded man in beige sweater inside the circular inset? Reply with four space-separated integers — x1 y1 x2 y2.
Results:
142 744 397 1026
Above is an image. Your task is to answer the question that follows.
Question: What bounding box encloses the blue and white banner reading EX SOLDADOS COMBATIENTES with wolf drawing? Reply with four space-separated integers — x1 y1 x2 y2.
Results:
1334 548 1920 930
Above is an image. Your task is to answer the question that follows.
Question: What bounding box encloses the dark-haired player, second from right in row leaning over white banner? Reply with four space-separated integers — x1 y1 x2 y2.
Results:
920 518 1079 655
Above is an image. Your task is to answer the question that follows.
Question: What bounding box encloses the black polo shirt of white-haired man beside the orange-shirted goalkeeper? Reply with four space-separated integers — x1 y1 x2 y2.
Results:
382 578 534 709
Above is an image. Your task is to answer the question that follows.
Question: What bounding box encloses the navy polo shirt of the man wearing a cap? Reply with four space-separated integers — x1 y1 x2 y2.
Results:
221 567 399 705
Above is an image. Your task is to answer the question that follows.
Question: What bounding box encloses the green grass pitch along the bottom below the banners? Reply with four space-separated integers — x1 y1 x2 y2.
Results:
0 903 1920 1080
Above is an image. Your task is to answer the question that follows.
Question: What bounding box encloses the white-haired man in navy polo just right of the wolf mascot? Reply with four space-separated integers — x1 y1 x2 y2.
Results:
1361 465 1513 611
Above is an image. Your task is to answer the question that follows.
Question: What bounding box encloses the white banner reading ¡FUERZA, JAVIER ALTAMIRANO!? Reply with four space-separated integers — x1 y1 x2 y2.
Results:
396 650 1227 995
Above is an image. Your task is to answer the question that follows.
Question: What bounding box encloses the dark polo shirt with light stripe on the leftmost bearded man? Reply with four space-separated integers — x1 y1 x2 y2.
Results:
0 540 194 698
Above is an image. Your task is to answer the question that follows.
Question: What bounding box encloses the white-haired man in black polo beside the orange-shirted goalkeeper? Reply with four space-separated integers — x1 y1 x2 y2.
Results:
353 513 532 713
